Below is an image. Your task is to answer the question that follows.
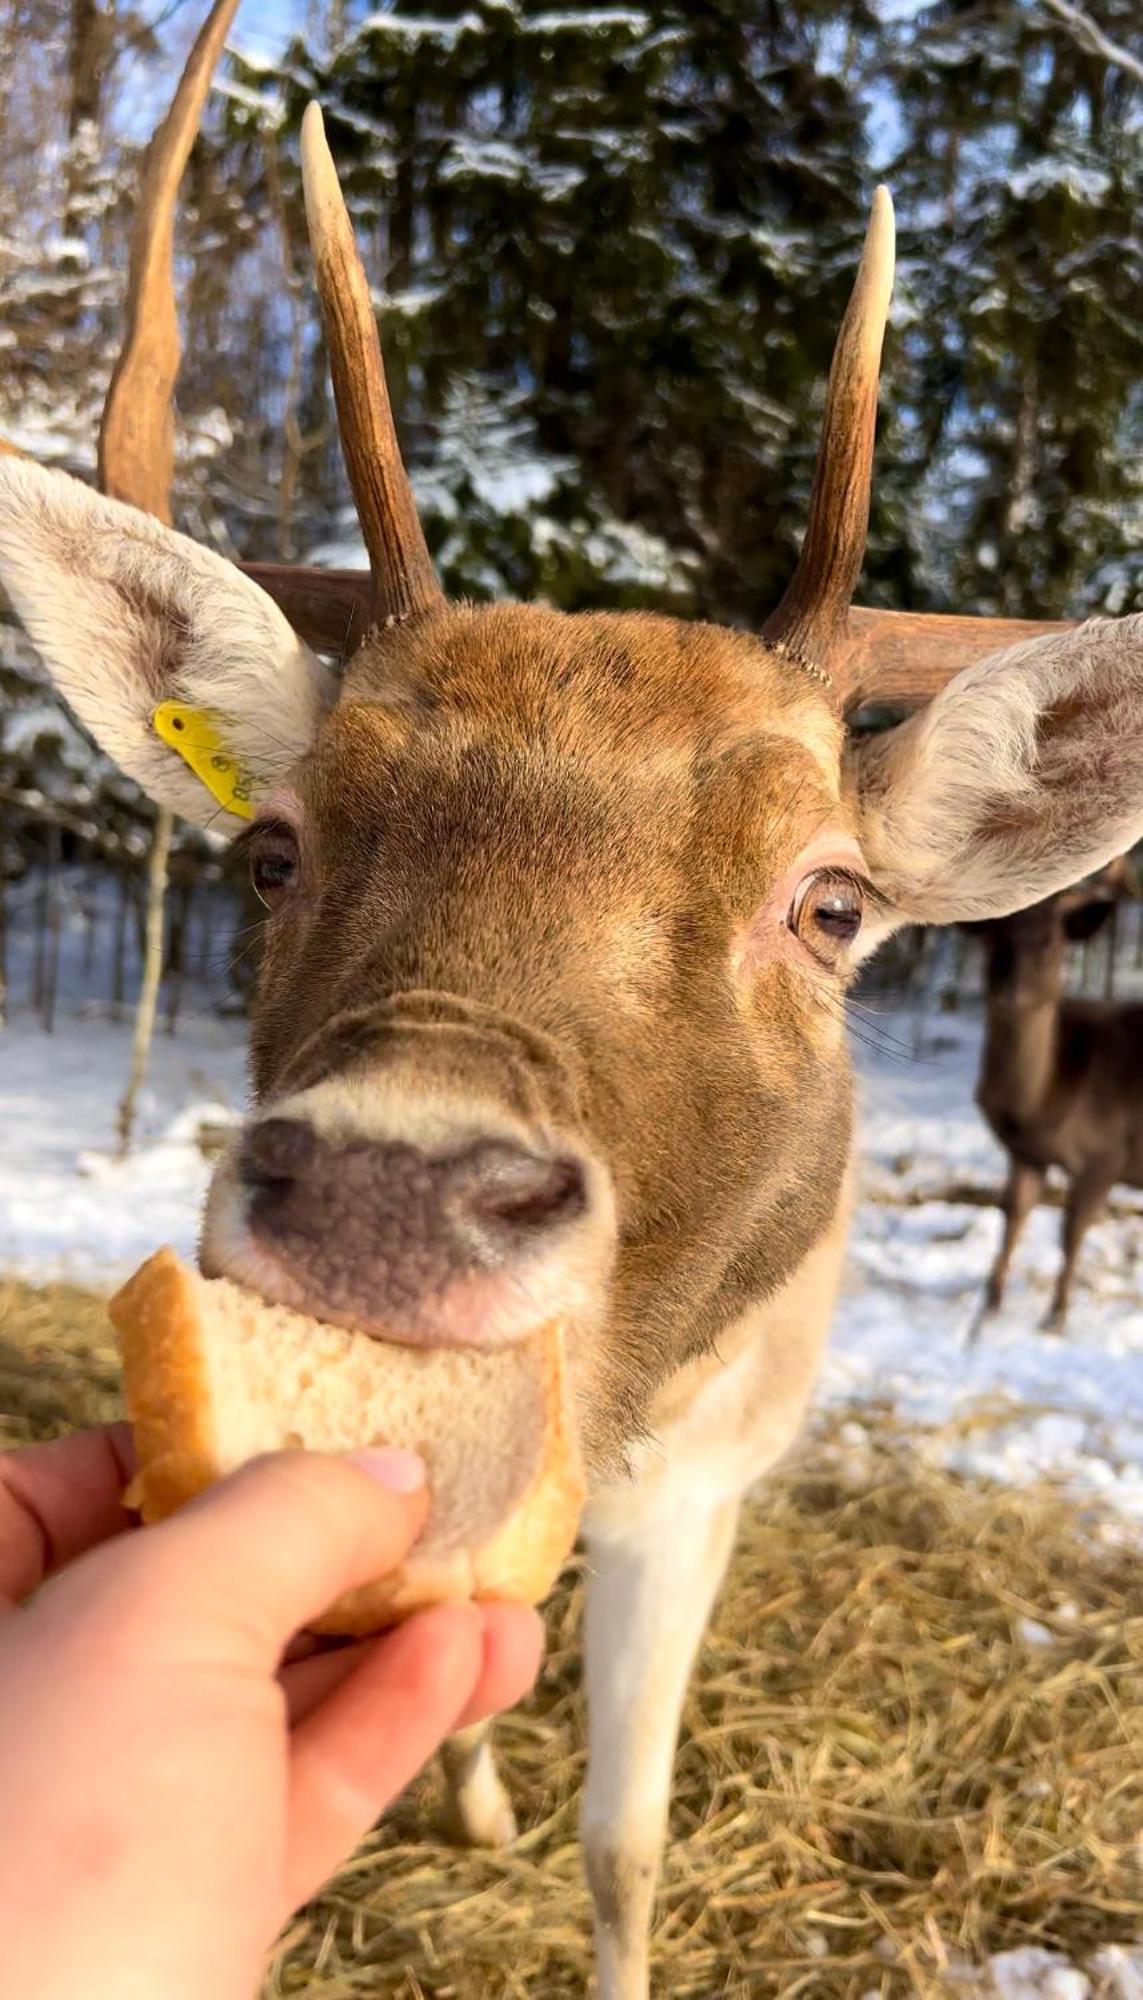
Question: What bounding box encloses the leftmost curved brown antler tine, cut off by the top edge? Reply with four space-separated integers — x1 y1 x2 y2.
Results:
100 0 238 522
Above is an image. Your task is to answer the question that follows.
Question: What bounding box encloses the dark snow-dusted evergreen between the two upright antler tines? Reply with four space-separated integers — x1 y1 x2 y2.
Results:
234 0 891 618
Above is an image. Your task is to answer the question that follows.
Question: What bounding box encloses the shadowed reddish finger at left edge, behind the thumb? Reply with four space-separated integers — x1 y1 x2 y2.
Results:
0 1424 134 1606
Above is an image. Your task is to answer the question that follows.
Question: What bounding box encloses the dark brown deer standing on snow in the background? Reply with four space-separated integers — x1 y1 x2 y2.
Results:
969 860 1143 1340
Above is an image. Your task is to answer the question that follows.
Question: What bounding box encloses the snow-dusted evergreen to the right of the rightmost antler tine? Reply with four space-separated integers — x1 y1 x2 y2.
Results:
891 0 1143 616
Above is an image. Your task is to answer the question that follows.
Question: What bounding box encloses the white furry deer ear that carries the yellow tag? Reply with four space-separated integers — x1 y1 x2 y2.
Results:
0 458 334 826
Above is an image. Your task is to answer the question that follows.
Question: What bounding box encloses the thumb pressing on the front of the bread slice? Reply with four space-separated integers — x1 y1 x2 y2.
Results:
40 1448 428 1670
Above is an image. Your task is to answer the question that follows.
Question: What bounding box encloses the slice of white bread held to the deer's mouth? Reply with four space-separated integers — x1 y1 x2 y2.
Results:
110 1250 583 1634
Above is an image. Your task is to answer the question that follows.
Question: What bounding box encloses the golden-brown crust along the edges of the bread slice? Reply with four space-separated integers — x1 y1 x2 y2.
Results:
108 1248 583 1638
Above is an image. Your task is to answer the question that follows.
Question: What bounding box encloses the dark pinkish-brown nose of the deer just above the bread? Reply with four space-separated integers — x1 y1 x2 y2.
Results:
238 1118 589 1344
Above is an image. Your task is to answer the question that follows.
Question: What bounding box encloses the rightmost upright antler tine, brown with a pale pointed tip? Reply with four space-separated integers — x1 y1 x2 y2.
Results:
761 188 895 688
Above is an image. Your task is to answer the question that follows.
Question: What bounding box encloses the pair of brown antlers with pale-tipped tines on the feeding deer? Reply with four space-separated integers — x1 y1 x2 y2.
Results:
0 56 1069 708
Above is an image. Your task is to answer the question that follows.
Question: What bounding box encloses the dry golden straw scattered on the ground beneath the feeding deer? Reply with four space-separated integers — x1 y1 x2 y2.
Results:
0 1288 1143 2000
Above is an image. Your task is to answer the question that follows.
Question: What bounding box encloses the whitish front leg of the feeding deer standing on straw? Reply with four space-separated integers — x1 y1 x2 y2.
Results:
583 1490 737 2000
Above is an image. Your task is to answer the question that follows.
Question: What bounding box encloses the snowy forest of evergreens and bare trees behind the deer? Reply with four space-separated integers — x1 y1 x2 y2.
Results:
0 0 1143 1006
